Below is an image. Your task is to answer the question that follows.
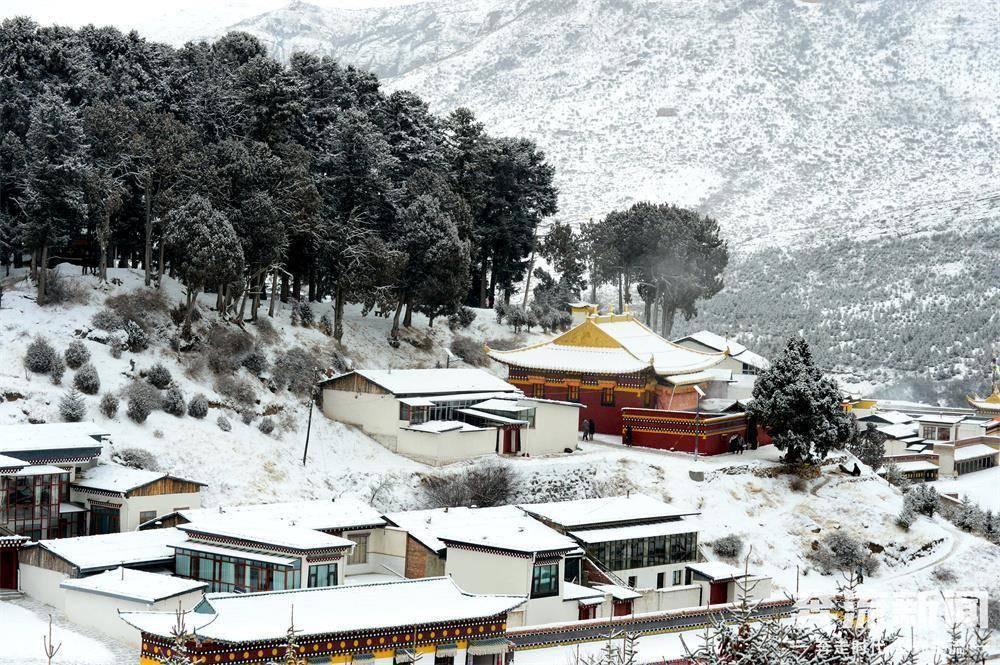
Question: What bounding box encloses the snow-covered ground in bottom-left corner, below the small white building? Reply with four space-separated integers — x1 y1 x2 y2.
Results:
0 598 138 665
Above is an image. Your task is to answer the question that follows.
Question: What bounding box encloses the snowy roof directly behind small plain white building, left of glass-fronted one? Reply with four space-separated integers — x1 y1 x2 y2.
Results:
39 529 186 571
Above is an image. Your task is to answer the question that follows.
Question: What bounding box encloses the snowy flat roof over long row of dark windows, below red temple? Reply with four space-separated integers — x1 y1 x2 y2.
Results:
520 493 697 529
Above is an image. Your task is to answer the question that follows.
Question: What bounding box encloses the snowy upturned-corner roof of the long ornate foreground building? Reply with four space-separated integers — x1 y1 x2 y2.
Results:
121 577 525 642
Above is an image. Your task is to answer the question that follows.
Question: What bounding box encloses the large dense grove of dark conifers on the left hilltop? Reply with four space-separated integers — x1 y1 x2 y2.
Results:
0 18 557 339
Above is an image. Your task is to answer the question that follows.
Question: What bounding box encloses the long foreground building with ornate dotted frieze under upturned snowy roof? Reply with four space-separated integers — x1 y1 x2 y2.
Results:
122 578 524 665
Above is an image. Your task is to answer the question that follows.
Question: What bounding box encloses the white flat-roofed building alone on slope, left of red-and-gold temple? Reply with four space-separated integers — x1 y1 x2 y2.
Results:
320 368 583 464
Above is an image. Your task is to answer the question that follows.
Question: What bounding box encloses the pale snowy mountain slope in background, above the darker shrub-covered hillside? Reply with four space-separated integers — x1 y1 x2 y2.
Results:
225 0 1000 245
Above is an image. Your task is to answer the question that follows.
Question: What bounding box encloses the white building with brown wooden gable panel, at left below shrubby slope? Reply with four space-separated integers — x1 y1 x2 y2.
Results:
70 464 205 535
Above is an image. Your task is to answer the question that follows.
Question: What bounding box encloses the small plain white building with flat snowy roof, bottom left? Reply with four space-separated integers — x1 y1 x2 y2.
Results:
59 568 205 647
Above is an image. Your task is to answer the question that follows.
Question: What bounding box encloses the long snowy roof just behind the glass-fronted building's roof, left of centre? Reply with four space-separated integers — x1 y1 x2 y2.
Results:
170 496 385 531
